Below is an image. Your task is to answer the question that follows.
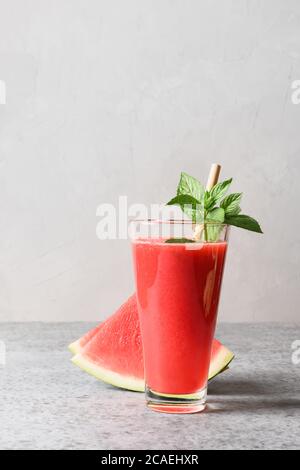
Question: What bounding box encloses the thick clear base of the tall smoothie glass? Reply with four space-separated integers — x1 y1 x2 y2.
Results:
145 386 207 414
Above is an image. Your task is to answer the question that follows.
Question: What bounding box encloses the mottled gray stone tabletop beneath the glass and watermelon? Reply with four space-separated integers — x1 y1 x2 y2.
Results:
0 323 300 450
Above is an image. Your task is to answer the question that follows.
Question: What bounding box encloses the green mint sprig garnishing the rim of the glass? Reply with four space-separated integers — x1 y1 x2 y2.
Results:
167 173 263 241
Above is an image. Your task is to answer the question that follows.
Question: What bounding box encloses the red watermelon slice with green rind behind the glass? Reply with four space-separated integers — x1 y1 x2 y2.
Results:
69 294 234 392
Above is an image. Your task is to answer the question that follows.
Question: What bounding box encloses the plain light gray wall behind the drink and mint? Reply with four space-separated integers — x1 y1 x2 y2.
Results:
0 0 300 321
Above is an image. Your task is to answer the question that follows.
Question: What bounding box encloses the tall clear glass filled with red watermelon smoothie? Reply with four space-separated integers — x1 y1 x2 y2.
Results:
130 220 228 413
